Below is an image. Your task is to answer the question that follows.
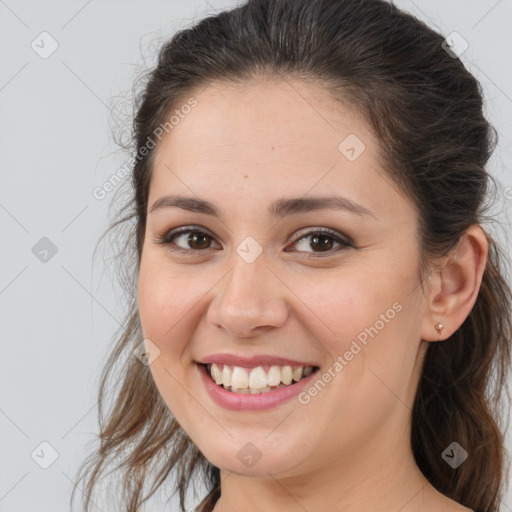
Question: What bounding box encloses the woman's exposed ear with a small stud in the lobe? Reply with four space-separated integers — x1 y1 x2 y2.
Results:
421 225 489 341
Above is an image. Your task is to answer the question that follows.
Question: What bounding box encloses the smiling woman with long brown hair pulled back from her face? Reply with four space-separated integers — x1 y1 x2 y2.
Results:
70 0 512 512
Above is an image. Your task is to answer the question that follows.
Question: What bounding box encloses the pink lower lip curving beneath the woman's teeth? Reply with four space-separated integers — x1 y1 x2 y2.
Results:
197 364 319 411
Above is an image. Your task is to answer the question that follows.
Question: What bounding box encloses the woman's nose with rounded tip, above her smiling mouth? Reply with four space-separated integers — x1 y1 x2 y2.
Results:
207 255 288 338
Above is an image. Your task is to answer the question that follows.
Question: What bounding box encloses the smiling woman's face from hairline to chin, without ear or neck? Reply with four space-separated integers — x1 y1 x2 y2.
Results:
138 80 427 477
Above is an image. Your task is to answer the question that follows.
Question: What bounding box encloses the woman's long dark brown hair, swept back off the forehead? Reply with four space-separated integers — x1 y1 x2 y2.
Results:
71 0 512 512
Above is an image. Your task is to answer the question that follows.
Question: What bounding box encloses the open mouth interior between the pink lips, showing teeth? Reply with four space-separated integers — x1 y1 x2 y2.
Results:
201 363 320 395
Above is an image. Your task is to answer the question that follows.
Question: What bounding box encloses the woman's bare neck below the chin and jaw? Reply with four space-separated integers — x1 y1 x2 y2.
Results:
209 438 456 512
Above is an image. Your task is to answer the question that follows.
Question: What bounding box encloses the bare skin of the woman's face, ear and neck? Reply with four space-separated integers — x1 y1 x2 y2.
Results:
138 79 488 512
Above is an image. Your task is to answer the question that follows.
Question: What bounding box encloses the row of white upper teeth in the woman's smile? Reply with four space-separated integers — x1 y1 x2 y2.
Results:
208 363 313 389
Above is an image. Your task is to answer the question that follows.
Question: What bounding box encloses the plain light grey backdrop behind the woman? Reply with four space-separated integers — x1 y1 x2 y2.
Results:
0 0 512 512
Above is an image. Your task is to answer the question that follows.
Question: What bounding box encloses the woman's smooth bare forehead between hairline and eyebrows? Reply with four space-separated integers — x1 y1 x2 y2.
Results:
149 80 403 224
